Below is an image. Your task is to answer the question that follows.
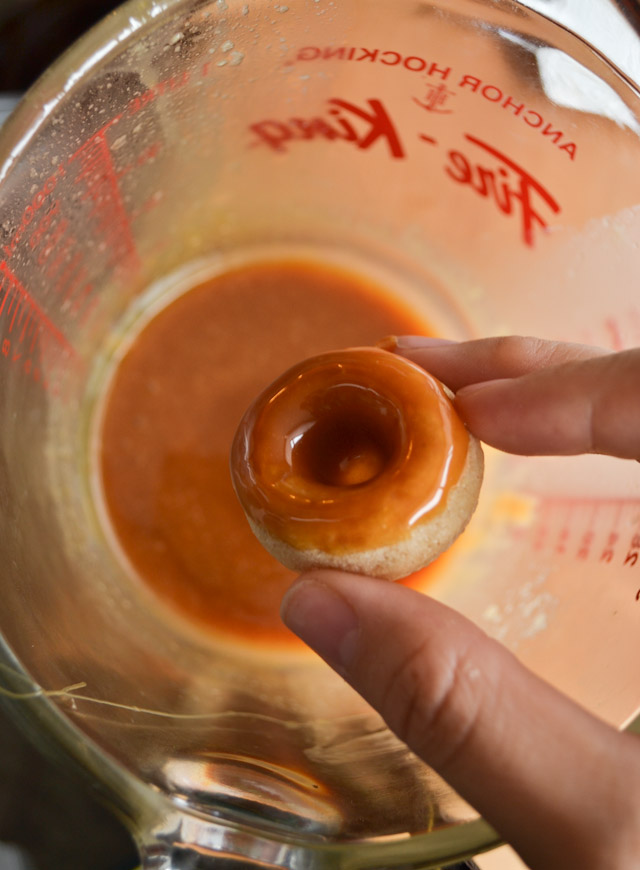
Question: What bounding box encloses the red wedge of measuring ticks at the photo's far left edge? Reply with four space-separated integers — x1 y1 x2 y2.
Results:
0 260 75 359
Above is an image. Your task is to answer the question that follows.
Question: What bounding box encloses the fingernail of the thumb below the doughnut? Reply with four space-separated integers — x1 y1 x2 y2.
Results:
281 578 359 676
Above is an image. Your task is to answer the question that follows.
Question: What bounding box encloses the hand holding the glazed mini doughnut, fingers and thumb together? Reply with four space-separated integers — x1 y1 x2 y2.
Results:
282 337 640 870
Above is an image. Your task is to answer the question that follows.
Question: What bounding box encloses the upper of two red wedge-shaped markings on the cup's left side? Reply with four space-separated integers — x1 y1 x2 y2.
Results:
69 127 138 267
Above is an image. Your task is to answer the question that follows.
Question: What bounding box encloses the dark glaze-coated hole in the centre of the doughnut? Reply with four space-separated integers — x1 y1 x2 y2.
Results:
290 384 403 488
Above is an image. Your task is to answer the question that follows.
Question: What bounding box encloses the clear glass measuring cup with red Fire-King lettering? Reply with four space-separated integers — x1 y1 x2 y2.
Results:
0 0 640 868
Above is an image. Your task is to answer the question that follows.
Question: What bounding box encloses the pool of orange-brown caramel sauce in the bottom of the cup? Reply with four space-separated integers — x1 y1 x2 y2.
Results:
98 260 440 644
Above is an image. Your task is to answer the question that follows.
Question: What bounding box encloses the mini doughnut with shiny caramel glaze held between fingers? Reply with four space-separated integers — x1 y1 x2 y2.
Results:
231 348 483 580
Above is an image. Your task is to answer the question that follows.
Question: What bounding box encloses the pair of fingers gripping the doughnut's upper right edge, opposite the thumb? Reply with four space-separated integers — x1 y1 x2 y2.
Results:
384 336 640 459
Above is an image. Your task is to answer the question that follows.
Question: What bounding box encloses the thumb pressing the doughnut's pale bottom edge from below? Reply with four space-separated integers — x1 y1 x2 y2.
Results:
282 571 640 870
